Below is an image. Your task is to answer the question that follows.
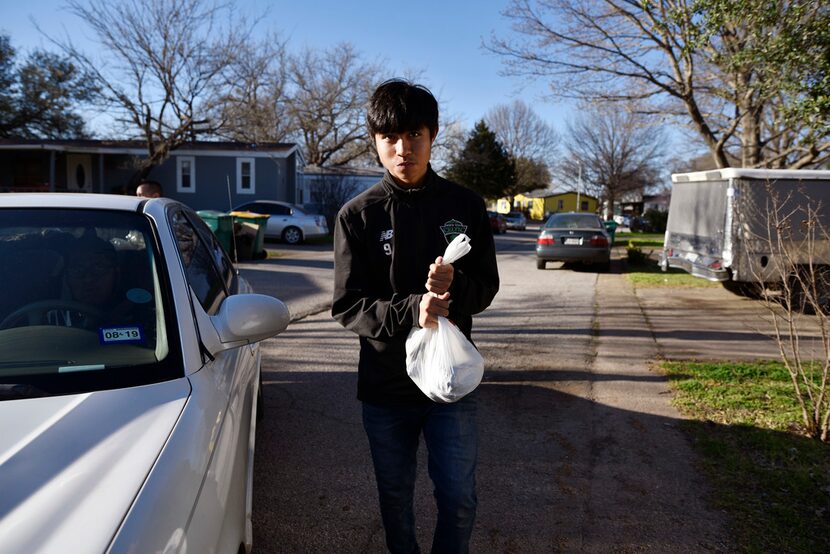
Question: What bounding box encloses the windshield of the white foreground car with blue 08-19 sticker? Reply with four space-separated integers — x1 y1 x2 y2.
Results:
0 209 181 400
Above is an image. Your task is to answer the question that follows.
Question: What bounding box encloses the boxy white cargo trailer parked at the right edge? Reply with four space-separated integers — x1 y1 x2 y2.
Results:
660 168 830 294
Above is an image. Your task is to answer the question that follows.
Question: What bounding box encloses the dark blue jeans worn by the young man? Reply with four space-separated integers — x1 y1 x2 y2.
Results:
363 392 478 554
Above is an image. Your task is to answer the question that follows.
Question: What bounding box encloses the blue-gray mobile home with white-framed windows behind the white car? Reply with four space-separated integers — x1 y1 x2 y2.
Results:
0 139 305 211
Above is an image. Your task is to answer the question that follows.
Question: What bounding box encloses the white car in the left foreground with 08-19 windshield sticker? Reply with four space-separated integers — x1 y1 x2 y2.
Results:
0 193 289 553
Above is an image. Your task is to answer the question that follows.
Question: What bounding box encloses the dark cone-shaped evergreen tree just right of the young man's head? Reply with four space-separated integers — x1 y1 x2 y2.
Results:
447 120 516 198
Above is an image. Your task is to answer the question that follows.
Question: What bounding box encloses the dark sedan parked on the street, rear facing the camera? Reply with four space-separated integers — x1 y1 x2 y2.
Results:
536 213 611 271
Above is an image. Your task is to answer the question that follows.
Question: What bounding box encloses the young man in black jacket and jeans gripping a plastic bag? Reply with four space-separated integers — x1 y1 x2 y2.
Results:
332 80 499 553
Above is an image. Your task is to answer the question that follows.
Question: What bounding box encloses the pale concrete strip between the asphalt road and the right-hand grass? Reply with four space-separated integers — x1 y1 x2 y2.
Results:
583 274 730 552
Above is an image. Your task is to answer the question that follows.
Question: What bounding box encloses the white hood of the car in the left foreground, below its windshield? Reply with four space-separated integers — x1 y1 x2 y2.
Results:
0 378 190 552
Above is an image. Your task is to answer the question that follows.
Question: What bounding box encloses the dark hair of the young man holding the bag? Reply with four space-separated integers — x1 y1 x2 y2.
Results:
366 79 438 140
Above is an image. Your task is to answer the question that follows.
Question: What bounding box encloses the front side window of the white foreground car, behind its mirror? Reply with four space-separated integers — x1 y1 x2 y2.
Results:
170 209 227 315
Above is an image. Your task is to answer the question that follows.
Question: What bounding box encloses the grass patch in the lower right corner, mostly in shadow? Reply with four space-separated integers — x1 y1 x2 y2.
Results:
660 362 830 553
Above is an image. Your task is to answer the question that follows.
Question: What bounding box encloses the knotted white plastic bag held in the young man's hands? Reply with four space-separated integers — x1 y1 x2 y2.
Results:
406 234 484 403
